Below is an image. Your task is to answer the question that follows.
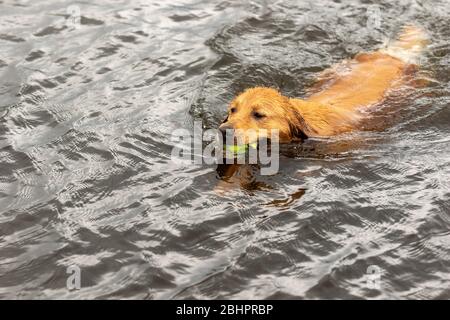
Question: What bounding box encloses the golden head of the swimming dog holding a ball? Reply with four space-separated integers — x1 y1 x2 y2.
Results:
219 87 306 144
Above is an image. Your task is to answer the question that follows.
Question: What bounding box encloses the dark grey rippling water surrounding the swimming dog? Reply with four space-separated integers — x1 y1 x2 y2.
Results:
0 0 450 299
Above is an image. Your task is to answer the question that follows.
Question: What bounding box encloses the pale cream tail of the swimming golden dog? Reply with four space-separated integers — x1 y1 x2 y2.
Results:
382 25 429 64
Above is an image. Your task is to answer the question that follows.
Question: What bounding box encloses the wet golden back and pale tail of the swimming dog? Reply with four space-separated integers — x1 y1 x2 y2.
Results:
297 26 427 135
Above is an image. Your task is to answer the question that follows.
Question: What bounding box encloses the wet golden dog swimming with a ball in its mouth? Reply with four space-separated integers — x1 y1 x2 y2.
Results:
219 25 428 144
